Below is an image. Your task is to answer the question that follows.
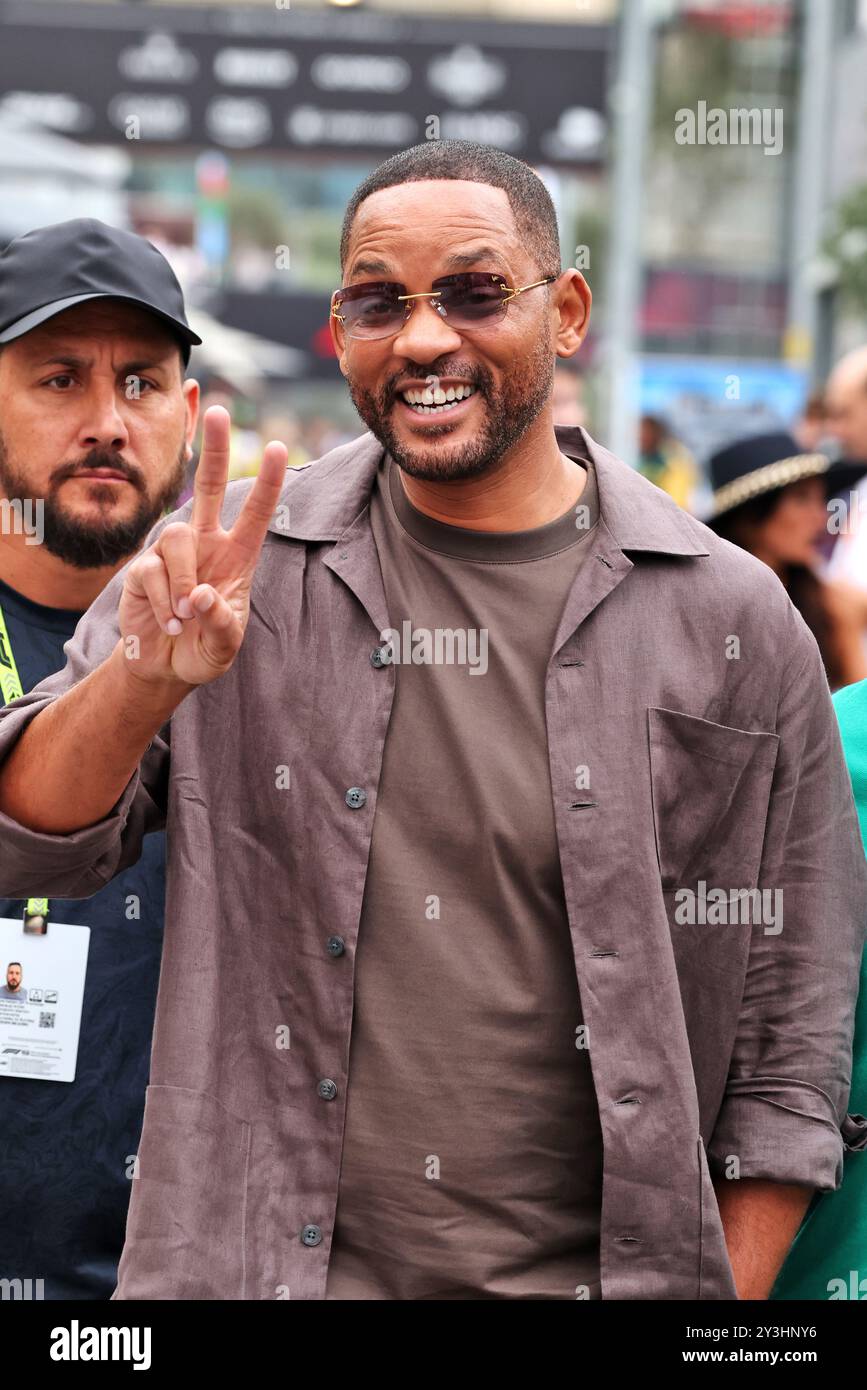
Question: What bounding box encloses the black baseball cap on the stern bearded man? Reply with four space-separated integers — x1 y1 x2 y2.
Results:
0 217 201 364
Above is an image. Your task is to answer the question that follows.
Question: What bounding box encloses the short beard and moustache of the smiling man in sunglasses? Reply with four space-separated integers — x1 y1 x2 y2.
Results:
341 339 554 482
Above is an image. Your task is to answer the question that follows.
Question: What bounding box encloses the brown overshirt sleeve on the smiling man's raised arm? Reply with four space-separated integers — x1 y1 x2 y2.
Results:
0 505 180 898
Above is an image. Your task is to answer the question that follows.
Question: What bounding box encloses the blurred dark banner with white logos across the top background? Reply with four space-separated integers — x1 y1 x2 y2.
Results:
0 0 613 165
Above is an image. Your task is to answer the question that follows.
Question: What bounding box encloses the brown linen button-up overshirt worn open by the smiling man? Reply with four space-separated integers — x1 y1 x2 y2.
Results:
0 427 867 1300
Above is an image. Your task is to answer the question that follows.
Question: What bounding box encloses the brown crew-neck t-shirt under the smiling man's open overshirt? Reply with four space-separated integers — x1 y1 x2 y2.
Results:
325 453 602 1300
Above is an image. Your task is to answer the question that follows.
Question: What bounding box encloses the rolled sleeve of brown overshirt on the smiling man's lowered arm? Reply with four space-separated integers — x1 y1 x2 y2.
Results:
707 607 867 1191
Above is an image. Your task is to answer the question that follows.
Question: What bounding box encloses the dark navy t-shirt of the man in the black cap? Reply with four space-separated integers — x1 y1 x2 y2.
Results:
0 569 165 1298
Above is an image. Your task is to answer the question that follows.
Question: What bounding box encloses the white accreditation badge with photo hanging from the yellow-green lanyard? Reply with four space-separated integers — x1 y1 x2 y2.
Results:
0 899 90 1081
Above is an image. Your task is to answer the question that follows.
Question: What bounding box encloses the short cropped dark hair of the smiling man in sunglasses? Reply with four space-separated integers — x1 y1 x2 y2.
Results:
340 140 560 279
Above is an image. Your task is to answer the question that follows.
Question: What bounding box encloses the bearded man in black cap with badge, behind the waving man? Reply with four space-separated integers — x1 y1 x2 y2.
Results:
0 218 200 1298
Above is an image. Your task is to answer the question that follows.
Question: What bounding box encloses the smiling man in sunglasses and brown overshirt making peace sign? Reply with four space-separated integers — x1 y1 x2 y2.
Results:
0 140 867 1300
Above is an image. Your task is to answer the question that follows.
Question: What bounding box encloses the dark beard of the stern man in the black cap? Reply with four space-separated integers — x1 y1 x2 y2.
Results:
0 435 186 570
